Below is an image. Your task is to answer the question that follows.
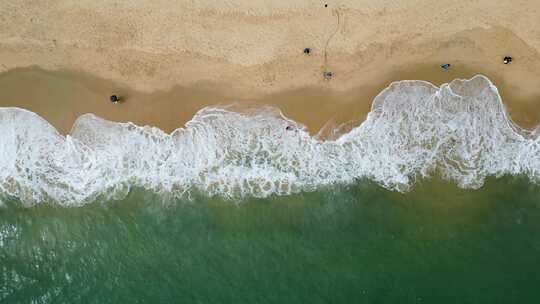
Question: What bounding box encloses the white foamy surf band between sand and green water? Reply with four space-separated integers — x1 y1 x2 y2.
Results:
0 75 540 206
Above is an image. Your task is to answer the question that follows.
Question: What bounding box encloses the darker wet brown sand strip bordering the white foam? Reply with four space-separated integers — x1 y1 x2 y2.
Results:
0 60 540 135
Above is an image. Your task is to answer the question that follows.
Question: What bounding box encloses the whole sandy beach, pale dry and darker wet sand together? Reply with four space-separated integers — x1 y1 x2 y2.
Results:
0 0 540 133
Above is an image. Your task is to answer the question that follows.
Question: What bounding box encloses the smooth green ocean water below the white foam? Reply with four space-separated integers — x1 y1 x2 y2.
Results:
0 178 540 303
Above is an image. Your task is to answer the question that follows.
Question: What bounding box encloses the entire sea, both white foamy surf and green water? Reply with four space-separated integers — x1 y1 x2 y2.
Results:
0 76 540 303
